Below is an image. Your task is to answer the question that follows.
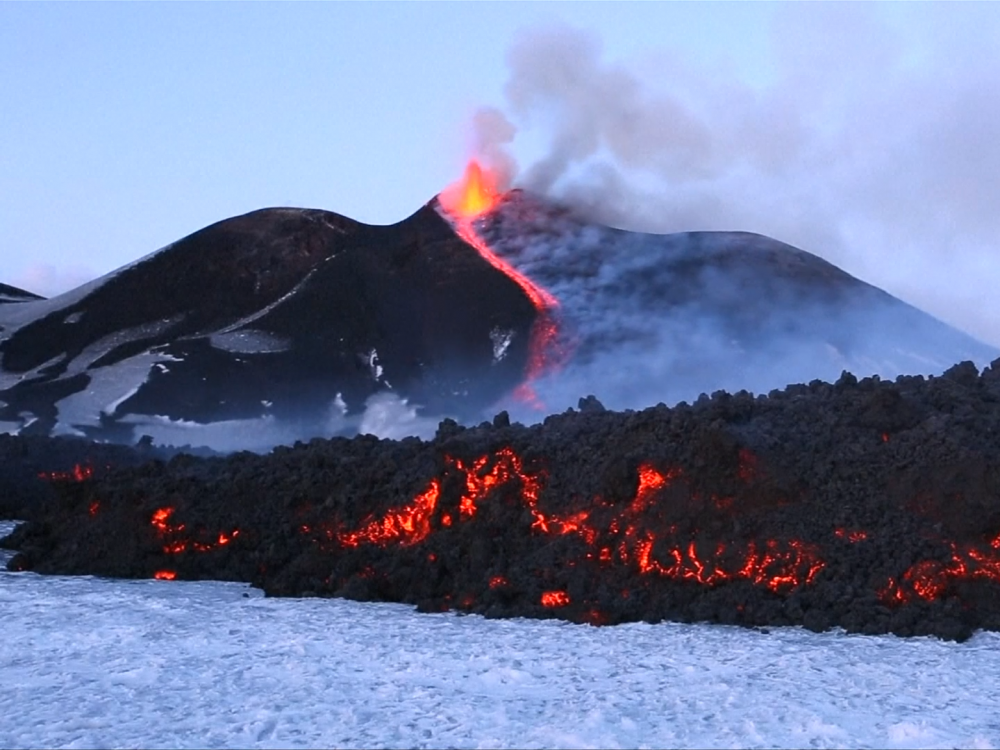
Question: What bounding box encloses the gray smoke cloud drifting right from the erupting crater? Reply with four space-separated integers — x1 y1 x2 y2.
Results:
476 4 1000 345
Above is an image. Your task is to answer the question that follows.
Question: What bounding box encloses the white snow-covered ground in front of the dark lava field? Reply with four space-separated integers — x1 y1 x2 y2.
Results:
0 524 1000 747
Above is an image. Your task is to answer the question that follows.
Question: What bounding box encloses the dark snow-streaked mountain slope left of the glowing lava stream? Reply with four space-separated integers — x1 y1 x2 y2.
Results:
0 208 533 445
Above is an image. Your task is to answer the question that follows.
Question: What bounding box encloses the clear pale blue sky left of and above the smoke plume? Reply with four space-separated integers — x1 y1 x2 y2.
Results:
0 3 768 280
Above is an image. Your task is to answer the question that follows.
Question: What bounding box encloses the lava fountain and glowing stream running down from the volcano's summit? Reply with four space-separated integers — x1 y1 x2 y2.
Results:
438 160 563 408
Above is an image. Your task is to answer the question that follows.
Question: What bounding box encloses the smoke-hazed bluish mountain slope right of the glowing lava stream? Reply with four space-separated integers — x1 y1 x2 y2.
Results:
479 191 1000 418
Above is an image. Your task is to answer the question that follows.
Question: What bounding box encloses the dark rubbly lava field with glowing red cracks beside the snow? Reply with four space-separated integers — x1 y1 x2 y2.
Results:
4 359 1000 640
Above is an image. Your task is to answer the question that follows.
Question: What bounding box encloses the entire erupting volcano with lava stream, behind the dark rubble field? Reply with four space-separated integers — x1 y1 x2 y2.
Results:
0 184 998 450
